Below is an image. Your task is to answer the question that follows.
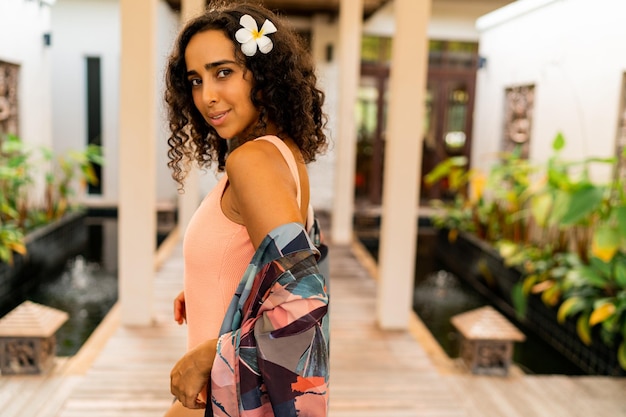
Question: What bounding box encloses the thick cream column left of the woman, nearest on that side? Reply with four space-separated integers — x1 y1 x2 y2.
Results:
118 0 158 326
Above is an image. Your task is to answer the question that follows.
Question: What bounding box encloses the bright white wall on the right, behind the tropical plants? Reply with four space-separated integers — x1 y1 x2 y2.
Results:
472 0 626 179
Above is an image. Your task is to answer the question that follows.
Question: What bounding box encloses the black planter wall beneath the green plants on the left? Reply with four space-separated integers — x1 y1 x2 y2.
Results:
0 212 88 315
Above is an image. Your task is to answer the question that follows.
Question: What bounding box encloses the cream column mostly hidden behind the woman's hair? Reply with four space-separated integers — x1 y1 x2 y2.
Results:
178 0 206 236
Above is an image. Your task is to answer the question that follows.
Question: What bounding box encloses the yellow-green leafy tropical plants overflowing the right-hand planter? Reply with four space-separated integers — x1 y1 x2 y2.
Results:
431 133 626 369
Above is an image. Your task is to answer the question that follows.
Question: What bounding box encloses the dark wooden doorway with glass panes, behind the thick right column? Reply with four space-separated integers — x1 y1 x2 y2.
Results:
355 40 479 205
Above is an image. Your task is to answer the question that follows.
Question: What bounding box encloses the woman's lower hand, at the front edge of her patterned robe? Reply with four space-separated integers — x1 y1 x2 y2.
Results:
170 339 217 409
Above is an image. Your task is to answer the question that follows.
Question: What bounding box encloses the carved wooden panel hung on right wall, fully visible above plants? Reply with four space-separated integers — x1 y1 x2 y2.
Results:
502 85 535 158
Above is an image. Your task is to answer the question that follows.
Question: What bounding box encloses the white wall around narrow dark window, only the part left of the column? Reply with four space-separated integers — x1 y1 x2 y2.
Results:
52 0 120 205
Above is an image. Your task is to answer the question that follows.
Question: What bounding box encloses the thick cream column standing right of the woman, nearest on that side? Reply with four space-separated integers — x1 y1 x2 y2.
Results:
377 0 431 329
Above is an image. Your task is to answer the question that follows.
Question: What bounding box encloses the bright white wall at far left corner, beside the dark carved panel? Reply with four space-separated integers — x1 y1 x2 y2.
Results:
0 0 52 146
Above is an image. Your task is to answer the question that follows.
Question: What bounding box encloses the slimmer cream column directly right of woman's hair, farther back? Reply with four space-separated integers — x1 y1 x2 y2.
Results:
331 0 363 244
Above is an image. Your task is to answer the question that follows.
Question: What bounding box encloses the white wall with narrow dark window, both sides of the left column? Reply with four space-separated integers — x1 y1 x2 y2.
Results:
52 0 178 206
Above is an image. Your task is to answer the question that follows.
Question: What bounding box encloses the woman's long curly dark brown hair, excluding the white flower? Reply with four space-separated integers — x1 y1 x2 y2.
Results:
165 1 327 187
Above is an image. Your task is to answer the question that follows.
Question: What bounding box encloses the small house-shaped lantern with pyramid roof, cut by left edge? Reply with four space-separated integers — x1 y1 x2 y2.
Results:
0 301 69 375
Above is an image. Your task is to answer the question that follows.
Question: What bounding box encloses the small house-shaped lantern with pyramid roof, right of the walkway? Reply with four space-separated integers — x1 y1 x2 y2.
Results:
450 306 526 376
